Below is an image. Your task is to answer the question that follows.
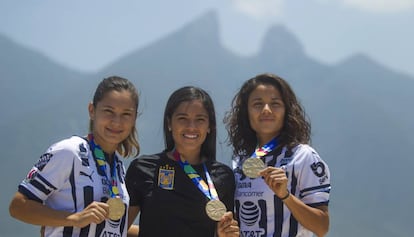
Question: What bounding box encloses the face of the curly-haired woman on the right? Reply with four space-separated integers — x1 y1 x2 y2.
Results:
247 84 285 146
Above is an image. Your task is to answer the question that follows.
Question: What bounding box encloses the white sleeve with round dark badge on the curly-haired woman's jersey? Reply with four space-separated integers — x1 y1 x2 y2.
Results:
294 145 331 206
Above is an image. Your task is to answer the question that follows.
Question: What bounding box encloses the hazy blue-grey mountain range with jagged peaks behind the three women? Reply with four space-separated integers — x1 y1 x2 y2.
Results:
0 12 414 237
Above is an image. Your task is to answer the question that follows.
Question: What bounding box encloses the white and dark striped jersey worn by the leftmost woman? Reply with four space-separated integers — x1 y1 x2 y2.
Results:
19 136 129 237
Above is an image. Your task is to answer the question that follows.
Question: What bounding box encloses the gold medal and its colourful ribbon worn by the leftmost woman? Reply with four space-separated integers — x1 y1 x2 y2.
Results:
88 134 125 220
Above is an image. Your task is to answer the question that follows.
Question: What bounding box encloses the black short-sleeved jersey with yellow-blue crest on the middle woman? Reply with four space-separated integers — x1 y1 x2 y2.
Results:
126 153 235 237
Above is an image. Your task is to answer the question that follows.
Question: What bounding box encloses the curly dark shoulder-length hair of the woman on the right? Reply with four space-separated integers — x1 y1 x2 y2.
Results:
223 73 311 156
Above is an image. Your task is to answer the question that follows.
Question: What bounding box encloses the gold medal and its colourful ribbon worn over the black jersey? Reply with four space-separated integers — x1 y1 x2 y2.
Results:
173 150 226 221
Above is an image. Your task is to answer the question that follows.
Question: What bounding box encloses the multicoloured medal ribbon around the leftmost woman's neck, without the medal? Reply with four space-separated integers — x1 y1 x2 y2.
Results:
88 134 119 198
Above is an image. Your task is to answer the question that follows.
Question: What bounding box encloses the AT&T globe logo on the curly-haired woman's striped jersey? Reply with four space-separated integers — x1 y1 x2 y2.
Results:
239 201 265 237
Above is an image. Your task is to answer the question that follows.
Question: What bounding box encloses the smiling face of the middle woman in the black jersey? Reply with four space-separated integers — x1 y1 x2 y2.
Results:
169 100 210 155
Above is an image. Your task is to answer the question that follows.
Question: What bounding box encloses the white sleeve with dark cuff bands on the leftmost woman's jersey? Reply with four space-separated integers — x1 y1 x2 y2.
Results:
19 140 75 202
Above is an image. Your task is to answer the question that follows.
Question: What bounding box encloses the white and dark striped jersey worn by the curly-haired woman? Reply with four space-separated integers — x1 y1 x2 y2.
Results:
233 144 331 237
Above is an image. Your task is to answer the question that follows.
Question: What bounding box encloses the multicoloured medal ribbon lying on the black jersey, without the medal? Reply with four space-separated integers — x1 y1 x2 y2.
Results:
173 149 219 200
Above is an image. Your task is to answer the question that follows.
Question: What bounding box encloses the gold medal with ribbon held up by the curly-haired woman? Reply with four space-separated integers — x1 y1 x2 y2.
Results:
242 138 277 179
